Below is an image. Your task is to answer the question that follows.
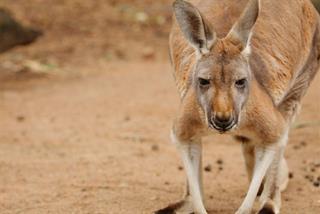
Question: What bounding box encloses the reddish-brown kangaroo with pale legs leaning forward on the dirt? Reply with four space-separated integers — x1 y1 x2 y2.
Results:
156 0 320 214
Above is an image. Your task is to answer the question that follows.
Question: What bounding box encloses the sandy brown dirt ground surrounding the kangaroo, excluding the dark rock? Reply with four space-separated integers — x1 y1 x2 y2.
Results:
0 0 320 214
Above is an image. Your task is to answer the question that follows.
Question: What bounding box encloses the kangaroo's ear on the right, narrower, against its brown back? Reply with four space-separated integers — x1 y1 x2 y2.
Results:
227 0 259 48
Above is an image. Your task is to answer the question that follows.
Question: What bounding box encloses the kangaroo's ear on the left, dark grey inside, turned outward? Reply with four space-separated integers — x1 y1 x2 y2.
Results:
173 0 216 54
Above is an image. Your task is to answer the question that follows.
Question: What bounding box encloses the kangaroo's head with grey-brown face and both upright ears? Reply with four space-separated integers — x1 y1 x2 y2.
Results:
173 0 259 132
